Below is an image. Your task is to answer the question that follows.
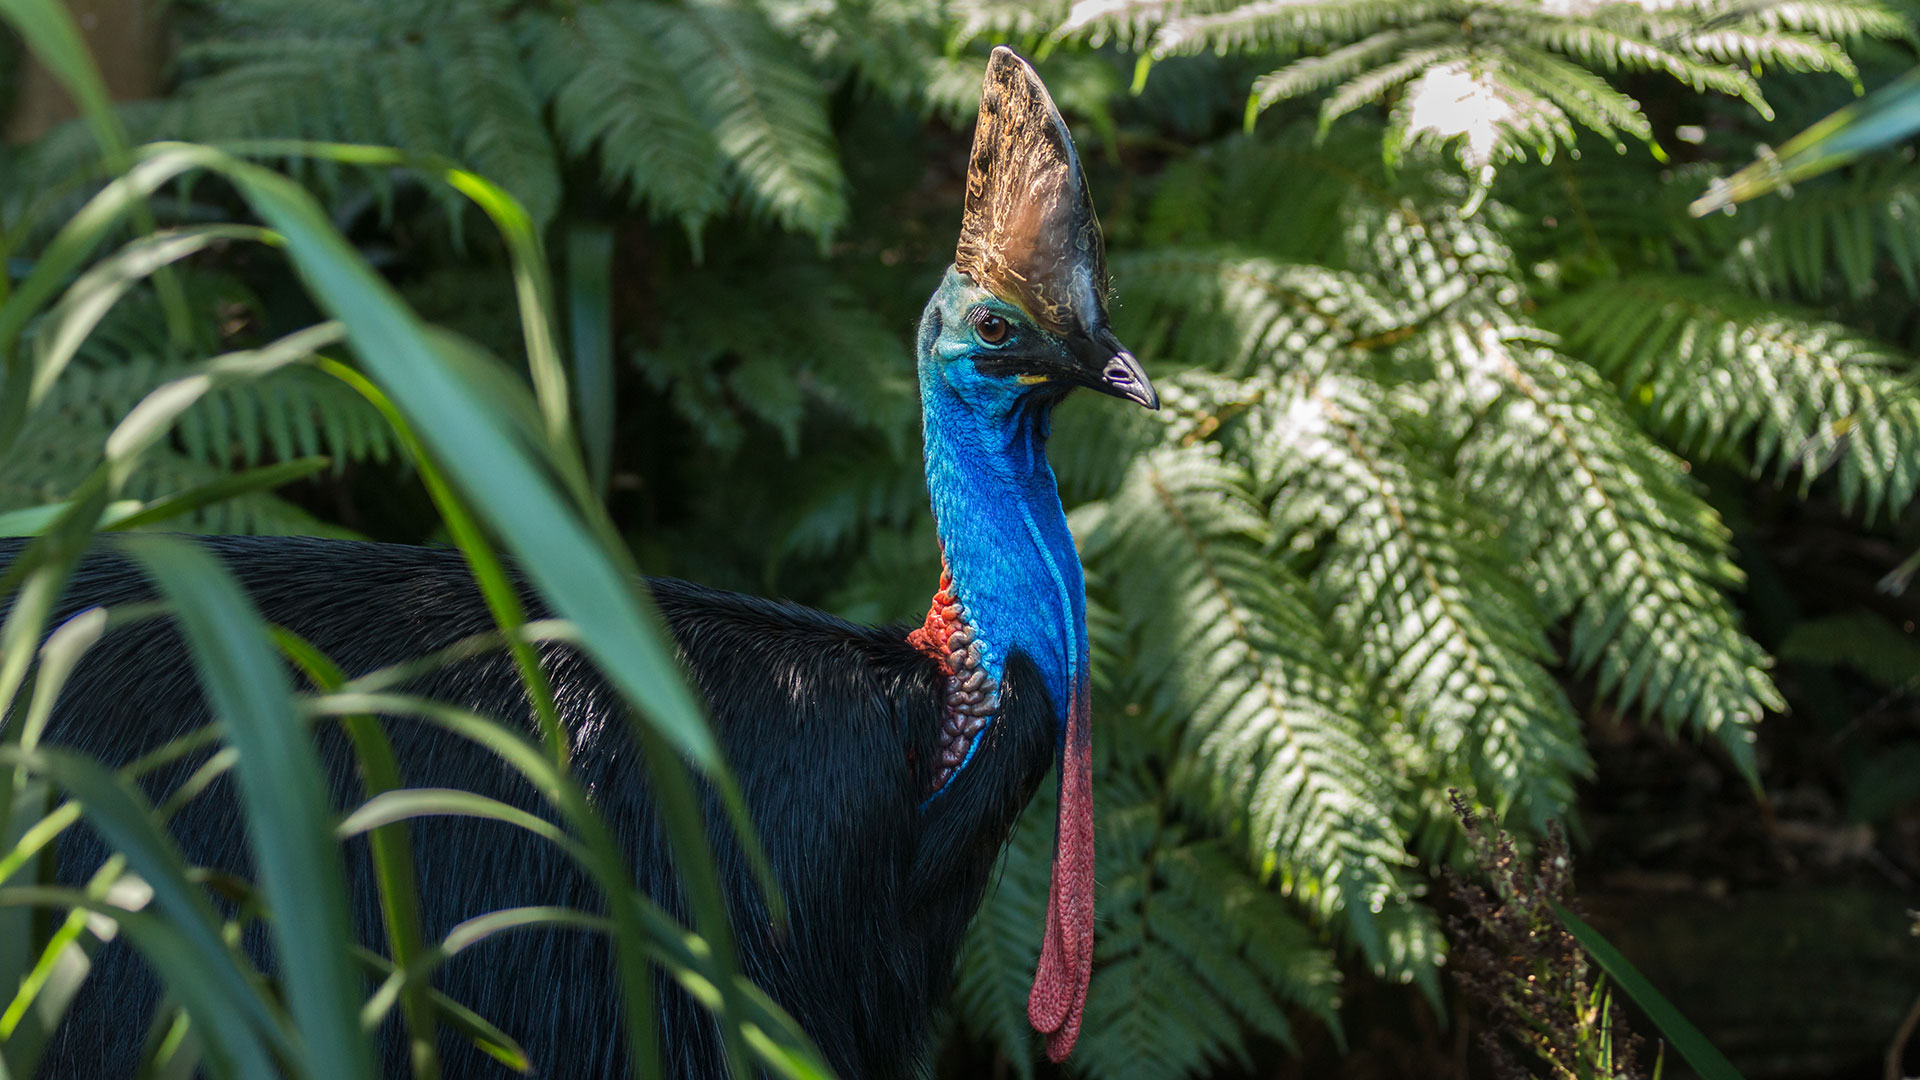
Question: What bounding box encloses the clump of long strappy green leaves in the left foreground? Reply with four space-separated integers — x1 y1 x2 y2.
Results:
0 0 824 1078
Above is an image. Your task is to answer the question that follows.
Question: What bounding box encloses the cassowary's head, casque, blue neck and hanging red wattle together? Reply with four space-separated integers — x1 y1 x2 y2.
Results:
908 48 1160 1061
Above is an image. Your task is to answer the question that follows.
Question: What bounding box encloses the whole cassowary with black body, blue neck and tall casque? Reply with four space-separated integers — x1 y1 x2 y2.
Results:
0 48 1158 1080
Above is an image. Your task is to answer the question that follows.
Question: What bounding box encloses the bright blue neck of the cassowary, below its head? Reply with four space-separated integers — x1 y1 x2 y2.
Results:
920 365 1089 724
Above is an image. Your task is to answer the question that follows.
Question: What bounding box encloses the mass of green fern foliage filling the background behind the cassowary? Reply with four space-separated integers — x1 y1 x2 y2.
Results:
0 0 1920 1078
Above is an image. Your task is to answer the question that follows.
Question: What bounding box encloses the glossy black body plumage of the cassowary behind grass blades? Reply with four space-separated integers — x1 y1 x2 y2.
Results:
0 538 1058 1080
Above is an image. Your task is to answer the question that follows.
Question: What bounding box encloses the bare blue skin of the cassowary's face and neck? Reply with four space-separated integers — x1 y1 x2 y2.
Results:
920 269 1089 790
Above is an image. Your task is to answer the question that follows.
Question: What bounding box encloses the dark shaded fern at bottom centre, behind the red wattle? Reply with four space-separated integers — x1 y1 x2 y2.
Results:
954 757 1338 1080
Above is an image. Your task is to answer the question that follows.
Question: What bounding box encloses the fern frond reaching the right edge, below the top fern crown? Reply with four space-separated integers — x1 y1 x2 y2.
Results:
1542 275 1920 519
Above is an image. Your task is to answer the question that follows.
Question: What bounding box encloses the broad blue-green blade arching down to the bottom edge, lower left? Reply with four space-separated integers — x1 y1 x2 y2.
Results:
127 538 372 1080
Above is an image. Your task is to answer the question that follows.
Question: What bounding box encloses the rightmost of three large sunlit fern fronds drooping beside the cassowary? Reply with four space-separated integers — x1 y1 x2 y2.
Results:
1461 338 1786 760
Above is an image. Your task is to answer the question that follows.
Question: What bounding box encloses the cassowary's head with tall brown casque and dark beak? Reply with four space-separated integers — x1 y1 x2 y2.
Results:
920 46 1160 415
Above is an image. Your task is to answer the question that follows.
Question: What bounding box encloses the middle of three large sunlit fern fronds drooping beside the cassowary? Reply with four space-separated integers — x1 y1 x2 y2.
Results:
1246 377 1588 821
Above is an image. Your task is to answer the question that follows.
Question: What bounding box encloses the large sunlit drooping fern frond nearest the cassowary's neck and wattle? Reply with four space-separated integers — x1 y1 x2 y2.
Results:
1087 448 1405 963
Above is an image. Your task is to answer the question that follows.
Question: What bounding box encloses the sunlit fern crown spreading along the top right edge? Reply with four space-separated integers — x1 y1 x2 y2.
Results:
1060 0 1907 184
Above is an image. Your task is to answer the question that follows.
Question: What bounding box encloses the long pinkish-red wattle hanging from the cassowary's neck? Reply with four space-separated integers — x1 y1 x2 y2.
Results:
1027 688 1092 1061
